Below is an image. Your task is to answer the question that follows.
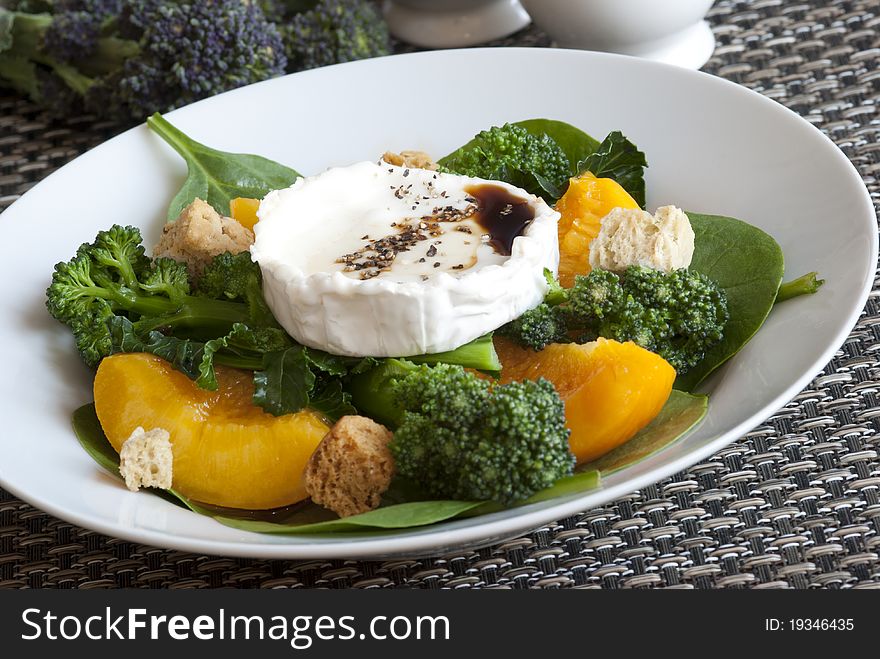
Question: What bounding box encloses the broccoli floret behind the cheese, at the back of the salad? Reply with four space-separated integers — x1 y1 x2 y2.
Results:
441 124 571 201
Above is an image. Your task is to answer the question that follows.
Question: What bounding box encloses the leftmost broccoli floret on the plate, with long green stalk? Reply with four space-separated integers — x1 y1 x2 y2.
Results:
46 225 265 366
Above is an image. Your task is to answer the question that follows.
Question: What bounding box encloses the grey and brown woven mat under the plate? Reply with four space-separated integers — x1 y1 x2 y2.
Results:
0 0 880 588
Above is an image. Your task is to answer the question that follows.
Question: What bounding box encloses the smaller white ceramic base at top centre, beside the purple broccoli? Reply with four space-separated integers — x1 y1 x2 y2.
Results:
382 0 531 48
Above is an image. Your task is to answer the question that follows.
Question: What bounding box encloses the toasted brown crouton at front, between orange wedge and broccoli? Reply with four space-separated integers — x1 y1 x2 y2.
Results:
305 416 394 517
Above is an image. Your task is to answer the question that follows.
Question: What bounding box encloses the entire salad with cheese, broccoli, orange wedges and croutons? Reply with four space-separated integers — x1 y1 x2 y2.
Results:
47 114 822 534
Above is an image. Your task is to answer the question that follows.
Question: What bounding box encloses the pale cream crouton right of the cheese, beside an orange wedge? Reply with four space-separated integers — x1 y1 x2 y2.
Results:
590 206 694 272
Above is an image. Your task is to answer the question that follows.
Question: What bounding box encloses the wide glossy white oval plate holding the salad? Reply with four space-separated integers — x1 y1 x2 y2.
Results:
0 49 877 558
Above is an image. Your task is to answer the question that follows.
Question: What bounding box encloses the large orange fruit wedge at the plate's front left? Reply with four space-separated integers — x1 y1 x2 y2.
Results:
94 353 329 509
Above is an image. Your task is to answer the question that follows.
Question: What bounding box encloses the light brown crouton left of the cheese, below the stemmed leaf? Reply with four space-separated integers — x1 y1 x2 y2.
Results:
153 199 254 281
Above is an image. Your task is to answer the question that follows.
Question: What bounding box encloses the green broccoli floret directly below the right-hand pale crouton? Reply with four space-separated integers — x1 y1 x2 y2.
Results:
567 266 729 373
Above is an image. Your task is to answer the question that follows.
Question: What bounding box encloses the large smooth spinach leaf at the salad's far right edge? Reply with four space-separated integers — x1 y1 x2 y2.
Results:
675 212 785 391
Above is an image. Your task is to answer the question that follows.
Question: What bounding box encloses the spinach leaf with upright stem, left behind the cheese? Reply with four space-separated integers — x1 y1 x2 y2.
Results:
147 112 300 222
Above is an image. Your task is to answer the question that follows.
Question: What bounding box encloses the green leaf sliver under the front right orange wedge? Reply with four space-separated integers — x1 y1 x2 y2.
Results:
582 389 709 474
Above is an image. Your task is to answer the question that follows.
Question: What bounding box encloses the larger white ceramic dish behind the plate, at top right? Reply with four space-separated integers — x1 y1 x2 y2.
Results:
522 0 715 69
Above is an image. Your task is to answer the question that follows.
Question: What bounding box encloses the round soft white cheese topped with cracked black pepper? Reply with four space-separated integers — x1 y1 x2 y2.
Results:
251 162 559 357
